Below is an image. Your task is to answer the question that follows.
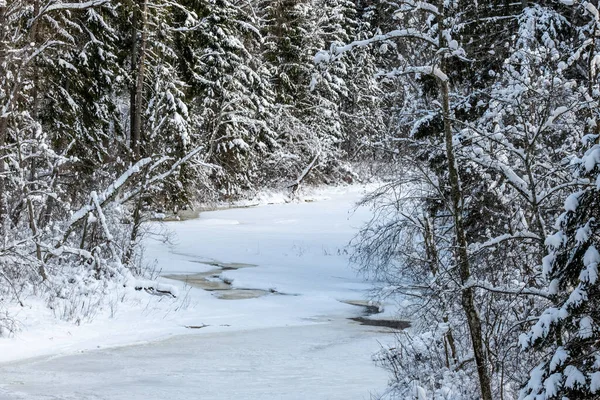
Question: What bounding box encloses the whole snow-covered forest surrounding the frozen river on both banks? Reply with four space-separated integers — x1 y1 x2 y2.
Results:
0 0 600 400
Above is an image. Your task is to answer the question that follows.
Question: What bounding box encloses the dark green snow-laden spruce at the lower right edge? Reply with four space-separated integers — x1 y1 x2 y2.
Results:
521 139 600 399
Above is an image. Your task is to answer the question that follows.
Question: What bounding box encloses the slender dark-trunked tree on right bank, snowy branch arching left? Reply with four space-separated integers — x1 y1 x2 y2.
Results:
321 1 500 400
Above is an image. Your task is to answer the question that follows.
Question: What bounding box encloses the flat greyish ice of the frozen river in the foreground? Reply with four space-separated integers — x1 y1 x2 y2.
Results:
0 322 386 400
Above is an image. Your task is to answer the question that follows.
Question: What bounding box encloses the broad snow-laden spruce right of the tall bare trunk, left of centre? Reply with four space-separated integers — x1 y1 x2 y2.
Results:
178 1 276 196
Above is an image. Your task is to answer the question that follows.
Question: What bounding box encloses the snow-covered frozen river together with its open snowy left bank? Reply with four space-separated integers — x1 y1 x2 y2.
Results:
0 186 400 399
